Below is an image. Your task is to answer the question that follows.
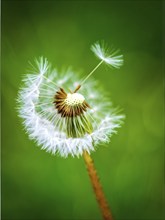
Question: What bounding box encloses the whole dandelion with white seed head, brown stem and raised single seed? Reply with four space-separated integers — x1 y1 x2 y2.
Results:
17 43 123 220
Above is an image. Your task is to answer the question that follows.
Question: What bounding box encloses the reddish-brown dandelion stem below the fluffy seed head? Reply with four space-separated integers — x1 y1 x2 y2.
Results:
83 151 113 220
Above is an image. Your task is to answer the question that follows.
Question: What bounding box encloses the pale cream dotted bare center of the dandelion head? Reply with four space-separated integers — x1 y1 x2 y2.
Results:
65 93 85 106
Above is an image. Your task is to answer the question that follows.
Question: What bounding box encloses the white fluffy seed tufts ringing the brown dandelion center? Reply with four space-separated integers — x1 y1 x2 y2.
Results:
17 53 124 157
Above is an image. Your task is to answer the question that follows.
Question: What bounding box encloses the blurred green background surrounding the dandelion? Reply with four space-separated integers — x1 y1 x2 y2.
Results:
2 1 164 220
